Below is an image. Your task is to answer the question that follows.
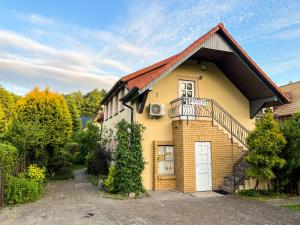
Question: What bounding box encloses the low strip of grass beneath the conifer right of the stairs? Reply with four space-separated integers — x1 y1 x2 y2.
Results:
237 189 287 201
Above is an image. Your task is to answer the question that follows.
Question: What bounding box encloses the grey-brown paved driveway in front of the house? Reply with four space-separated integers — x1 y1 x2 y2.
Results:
0 171 300 225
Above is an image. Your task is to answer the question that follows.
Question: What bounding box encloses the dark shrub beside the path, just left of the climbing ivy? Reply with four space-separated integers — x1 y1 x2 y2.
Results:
87 147 112 176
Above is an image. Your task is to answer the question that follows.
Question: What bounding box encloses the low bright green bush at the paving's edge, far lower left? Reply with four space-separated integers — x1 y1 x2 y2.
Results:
4 175 43 205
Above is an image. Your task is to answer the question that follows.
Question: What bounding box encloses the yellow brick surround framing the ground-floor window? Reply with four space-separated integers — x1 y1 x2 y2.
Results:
153 141 176 190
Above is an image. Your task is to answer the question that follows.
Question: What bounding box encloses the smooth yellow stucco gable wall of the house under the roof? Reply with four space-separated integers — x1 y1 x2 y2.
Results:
136 61 255 189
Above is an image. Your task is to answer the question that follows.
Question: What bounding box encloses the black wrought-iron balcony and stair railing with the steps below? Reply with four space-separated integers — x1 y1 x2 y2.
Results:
169 97 249 193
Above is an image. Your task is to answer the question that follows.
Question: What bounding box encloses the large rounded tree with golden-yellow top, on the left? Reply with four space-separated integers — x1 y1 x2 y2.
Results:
14 88 72 166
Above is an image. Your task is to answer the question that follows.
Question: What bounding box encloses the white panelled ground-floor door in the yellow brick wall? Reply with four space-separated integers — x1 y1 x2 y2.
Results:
195 142 212 191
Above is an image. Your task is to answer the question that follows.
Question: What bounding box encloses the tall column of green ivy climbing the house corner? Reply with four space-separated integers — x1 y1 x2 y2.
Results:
115 120 145 194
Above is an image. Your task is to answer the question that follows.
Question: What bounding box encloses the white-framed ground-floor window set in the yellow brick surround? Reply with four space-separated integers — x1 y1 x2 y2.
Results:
158 145 174 176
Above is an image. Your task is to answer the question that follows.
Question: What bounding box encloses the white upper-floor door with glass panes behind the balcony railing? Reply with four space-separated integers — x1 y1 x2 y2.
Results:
179 80 195 119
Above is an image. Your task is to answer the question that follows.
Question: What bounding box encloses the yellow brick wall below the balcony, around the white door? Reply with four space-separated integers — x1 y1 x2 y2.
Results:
172 120 243 192
